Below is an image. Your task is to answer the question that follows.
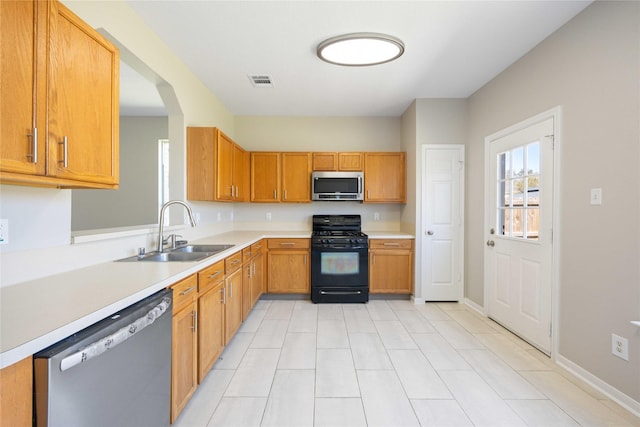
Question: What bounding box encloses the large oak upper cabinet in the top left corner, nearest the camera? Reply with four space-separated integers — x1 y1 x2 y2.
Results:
0 1 120 188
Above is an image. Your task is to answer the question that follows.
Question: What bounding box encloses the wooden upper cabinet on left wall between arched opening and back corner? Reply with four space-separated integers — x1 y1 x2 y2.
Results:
187 127 249 202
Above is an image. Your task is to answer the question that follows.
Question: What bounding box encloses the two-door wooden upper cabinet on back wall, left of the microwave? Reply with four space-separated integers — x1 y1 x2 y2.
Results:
251 152 311 203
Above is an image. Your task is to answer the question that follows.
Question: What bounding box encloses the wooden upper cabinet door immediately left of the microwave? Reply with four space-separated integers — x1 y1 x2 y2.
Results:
282 153 311 203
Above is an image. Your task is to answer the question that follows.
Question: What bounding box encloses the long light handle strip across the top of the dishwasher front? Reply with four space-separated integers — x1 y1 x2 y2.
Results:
60 297 171 372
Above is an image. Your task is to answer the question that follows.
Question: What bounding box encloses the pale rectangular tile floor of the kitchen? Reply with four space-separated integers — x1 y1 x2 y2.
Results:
175 300 640 427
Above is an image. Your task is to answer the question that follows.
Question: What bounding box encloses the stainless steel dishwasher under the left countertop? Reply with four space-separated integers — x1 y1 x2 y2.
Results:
33 289 173 427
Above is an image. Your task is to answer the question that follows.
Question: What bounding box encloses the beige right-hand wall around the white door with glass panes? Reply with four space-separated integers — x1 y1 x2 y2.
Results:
467 2 640 402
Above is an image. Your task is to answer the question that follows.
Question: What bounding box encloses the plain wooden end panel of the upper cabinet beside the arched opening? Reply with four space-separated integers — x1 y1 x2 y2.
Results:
187 127 215 201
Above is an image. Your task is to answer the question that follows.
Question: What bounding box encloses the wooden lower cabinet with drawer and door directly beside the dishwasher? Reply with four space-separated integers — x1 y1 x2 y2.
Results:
171 274 198 423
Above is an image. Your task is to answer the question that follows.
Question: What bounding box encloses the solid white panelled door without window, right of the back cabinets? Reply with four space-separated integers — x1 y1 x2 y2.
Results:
422 145 464 301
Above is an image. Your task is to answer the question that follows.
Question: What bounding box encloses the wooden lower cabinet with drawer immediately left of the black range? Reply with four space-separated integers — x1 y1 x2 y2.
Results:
267 239 311 293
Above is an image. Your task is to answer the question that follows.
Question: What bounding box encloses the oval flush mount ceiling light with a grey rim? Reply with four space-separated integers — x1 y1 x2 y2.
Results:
317 33 404 67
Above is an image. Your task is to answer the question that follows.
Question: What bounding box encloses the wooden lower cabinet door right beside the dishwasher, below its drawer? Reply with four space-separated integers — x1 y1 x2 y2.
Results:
171 301 198 423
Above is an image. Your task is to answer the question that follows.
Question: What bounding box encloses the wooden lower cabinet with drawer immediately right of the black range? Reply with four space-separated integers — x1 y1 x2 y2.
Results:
369 239 413 294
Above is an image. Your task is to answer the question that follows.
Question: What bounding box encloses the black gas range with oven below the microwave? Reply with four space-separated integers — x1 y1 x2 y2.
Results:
311 215 369 303
